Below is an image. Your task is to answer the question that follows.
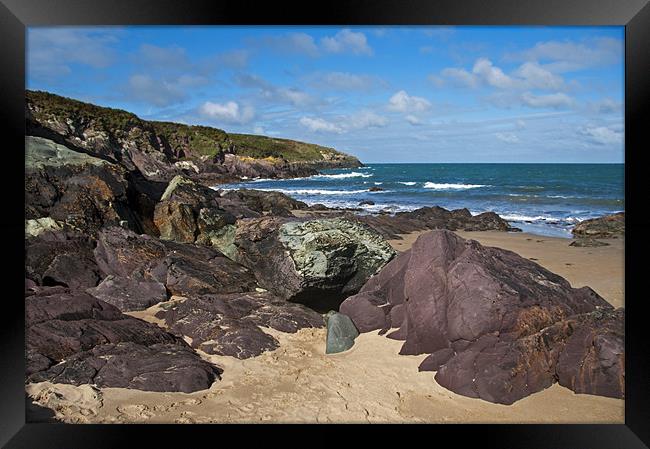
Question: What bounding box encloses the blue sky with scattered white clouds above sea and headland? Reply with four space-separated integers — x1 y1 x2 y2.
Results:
26 26 625 163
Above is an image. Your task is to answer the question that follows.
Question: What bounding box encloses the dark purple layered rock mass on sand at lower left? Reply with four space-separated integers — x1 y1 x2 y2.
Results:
25 287 220 392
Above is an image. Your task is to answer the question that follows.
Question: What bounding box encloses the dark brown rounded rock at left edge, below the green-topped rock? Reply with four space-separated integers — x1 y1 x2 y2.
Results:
25 230 101 289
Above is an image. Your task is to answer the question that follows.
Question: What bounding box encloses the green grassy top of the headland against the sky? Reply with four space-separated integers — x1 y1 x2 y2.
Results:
26 90 361 167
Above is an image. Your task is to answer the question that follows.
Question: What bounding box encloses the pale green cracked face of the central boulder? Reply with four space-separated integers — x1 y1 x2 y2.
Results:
278 218 396 291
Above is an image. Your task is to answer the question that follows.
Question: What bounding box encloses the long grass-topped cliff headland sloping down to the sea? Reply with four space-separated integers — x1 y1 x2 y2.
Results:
25 91 362 183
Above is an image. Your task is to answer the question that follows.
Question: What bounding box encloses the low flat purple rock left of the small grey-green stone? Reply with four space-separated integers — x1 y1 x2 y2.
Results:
157 292 323 359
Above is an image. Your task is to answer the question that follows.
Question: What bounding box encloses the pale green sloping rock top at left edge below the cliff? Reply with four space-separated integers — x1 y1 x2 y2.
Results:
25 136 109 168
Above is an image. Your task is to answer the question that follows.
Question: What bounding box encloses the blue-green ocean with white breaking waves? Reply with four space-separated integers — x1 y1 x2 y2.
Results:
215 164 625 238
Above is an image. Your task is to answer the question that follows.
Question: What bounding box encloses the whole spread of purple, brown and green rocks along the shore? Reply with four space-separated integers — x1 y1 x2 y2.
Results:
25 97 624 416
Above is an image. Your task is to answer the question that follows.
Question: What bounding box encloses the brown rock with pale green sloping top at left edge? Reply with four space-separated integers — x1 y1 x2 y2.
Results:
25 136 141 236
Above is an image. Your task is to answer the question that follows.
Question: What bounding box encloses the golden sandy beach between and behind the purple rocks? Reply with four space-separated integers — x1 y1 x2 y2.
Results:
27 231 624 423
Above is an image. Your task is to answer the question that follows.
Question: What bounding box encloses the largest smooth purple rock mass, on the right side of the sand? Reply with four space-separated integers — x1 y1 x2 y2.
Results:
340 230 624 404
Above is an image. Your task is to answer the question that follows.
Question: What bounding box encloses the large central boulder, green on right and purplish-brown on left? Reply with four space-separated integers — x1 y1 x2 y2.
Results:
221 217 395 312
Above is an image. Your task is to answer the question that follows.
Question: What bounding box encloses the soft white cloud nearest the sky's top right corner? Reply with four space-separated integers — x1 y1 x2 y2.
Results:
506 37 624 73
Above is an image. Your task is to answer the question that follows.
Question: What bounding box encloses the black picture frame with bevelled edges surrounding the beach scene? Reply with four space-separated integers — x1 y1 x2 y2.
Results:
0 0 650 449
